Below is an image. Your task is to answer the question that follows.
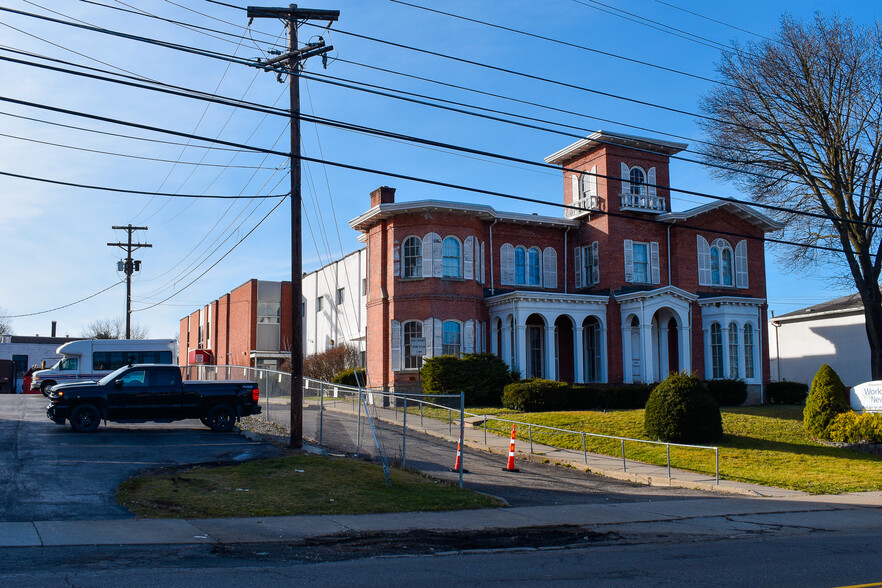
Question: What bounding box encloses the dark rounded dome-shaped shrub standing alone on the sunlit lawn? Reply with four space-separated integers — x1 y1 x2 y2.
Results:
643 374 723 443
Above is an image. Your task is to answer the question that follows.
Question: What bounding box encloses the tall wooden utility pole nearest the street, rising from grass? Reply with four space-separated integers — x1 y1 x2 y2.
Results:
247 4 340 449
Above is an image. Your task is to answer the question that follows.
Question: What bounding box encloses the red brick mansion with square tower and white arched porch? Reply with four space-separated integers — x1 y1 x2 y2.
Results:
350 132 780 396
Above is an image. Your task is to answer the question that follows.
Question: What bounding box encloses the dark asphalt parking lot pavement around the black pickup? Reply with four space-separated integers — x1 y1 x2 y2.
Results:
0 394 281 522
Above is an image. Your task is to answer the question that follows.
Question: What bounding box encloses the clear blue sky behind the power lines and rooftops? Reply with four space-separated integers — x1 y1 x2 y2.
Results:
0 0 877 337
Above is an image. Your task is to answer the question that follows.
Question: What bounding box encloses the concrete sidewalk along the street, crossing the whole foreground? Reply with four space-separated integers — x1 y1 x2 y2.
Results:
0 497 882 547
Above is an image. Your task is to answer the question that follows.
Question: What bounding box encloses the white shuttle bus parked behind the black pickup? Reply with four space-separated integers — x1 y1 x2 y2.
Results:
31 339 175 394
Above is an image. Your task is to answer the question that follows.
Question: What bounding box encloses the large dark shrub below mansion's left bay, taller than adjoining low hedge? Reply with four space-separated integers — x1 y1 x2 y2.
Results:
420 353 514 406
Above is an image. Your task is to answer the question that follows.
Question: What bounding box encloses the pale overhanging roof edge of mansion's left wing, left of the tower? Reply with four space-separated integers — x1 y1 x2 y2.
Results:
349 200 579 231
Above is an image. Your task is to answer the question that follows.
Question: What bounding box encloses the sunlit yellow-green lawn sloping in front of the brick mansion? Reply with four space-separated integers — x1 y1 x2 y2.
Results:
470 406 882 494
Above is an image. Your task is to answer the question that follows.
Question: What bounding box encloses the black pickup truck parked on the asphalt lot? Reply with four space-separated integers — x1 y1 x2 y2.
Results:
46 364 260 432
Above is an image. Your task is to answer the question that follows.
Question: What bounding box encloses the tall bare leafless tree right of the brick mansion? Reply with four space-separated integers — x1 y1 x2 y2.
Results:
701 14 882 380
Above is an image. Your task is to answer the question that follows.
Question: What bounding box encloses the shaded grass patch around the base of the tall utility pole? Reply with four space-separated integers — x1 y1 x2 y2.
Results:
117 455 504 518
